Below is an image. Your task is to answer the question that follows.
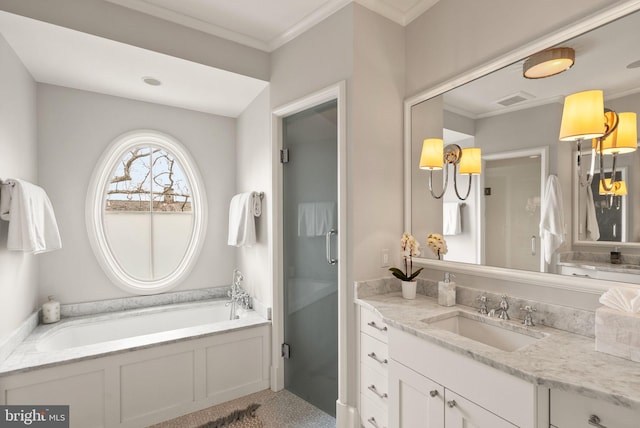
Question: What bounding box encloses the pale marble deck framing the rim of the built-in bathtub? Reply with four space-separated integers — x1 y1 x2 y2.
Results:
0 299 270 377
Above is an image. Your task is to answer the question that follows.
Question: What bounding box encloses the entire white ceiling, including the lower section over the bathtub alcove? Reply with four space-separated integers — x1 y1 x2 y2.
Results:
0 0 438 117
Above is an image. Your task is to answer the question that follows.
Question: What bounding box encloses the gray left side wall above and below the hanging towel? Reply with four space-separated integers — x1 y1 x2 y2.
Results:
0 36 38 343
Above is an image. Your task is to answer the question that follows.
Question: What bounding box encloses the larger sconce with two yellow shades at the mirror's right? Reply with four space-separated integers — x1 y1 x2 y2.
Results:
560 90 638 191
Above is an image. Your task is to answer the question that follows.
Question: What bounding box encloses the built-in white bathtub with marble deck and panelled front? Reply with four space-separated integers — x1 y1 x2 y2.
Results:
0 301 271 428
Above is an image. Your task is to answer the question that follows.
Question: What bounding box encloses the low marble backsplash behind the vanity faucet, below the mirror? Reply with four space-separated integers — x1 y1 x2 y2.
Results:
356 277 595 337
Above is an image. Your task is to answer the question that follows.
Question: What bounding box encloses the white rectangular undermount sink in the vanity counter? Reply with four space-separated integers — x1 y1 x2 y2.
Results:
422 312 544 352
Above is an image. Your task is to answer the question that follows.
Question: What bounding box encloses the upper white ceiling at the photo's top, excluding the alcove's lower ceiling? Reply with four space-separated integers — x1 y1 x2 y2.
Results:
107 0 439 52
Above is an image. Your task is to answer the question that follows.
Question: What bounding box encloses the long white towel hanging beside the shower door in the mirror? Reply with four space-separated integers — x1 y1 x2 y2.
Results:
540 175 565 263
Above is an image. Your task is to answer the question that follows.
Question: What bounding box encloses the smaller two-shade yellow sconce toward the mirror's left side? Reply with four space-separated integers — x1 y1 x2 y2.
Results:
420 138 482 201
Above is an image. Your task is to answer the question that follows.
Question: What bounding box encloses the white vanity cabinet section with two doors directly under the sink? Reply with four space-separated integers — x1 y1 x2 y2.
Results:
389 329 549 428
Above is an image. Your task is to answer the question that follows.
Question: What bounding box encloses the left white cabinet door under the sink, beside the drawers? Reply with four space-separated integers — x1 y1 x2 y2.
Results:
389 360 444 428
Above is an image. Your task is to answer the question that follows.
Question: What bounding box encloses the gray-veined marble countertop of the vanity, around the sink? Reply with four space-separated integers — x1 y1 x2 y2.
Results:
356 292 640 411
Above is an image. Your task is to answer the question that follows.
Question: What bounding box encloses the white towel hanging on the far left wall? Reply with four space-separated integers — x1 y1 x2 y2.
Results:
0 179 62 254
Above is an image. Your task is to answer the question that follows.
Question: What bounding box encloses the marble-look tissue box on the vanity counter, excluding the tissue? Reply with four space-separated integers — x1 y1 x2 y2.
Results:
596 306 640 362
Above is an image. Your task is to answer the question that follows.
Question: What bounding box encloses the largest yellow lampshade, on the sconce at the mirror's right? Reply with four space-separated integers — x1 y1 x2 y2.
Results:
560 90 605 141
